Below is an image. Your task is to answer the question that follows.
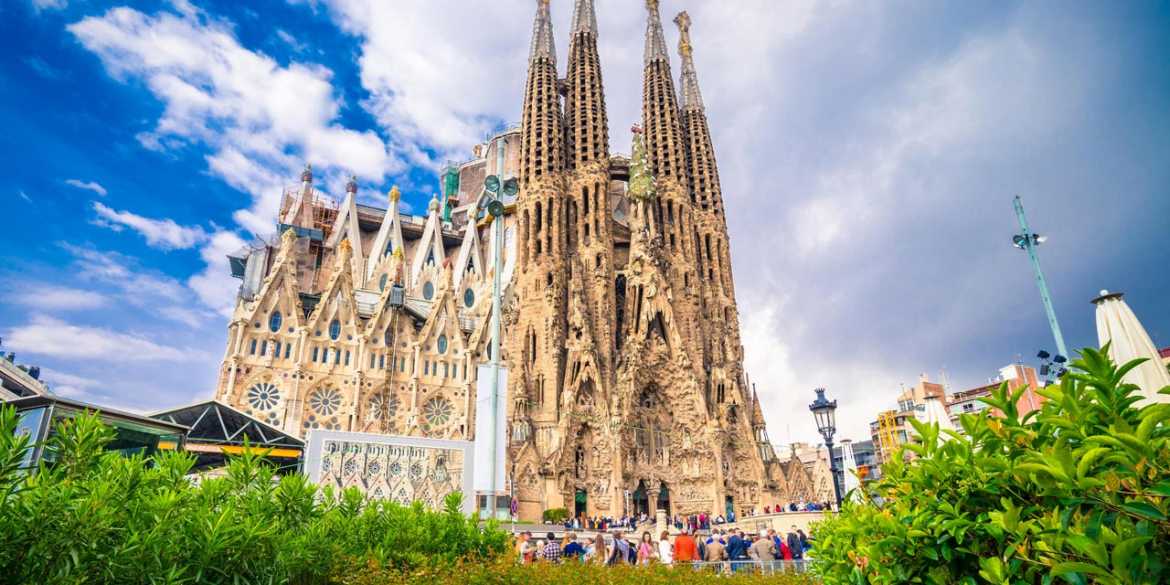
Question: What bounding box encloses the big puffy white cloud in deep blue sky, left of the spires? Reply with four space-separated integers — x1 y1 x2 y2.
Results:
68 4 402 234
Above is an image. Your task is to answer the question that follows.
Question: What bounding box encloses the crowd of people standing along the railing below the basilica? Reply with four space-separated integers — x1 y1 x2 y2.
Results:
516 526 811 571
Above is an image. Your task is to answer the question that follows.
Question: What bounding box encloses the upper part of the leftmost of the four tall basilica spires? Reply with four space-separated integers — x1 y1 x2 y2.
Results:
519 0 565 185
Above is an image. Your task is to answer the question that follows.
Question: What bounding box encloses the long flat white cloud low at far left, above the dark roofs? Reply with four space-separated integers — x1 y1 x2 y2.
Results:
5 315 196 363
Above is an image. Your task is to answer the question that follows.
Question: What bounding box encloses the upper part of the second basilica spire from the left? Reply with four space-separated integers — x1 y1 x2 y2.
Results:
565 0 610 167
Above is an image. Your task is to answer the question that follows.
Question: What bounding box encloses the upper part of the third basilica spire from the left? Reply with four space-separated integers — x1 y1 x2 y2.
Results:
642 0 687 186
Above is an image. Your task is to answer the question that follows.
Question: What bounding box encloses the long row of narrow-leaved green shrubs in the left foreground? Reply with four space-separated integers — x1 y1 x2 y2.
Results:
0 407 509 584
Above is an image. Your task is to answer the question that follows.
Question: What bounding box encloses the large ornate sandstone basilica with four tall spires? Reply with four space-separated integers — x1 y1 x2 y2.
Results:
216 0 821 518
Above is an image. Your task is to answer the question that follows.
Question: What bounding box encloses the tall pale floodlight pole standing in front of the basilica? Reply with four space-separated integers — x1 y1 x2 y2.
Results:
483 138 519 518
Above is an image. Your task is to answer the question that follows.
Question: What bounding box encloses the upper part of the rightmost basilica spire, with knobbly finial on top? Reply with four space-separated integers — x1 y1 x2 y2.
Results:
674 11 723 213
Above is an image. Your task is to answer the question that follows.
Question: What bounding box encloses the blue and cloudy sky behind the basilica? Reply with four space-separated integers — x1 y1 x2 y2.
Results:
0 0 1170 441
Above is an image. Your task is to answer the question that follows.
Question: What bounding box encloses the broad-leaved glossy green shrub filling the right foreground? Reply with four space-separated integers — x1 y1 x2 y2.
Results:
814 349 1170 584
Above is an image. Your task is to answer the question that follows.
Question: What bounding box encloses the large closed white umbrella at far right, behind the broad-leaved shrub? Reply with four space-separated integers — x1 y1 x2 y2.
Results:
1093 290 1170 402
